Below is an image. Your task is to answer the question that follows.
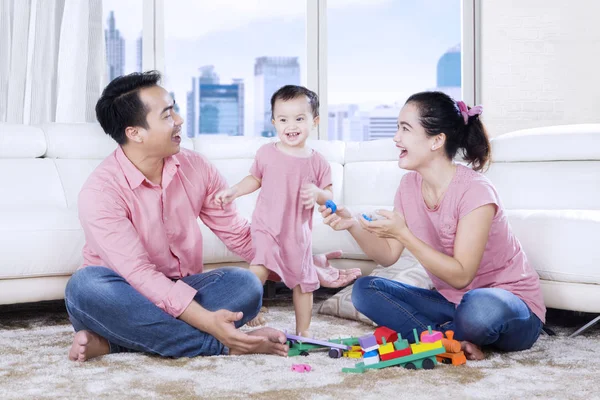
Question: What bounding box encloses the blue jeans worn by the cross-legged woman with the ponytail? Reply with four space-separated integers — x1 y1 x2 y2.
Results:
352 276 542 351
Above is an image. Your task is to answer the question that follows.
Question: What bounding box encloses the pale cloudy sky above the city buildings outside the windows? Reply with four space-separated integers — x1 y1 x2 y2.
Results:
103 0 461 136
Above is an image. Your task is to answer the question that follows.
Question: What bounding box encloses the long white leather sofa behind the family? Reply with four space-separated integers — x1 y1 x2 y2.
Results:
0 124 600 334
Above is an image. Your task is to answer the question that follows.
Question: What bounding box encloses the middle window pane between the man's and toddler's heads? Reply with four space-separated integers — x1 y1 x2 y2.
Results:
163 0 306 137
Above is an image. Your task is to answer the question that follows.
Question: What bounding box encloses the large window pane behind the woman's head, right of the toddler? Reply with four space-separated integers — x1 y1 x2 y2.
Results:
327 0 462 141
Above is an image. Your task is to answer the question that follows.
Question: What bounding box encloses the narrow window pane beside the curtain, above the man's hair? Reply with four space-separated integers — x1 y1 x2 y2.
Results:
102 0 143 82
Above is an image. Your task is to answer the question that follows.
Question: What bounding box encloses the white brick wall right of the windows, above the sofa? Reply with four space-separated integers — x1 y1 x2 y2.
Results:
478 0 600 136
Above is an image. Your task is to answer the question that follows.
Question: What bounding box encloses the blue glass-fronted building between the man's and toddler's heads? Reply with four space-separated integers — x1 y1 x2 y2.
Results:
187 65 244 137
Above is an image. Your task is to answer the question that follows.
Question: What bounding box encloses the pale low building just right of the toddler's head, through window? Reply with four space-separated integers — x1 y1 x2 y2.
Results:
327 104 369 141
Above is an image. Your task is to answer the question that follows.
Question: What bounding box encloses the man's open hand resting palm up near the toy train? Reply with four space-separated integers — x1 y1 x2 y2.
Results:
207 310 268 354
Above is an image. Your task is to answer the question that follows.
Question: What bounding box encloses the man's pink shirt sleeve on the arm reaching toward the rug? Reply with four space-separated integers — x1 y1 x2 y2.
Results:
79 189 197 317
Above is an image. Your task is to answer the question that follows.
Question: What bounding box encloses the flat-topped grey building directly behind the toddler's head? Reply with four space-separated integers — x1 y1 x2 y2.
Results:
254 57 300 137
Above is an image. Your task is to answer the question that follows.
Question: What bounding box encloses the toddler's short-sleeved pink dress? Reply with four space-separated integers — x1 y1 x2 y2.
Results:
250 143 331 293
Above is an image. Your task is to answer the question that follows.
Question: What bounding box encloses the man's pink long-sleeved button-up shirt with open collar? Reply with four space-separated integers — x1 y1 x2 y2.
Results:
79 147 254 317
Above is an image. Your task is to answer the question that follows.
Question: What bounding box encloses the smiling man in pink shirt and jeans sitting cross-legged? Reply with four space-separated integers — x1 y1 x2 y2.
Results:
65 72 287 361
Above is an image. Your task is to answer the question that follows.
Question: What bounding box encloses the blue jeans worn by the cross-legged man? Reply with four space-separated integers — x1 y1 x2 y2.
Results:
65 267 263 357
